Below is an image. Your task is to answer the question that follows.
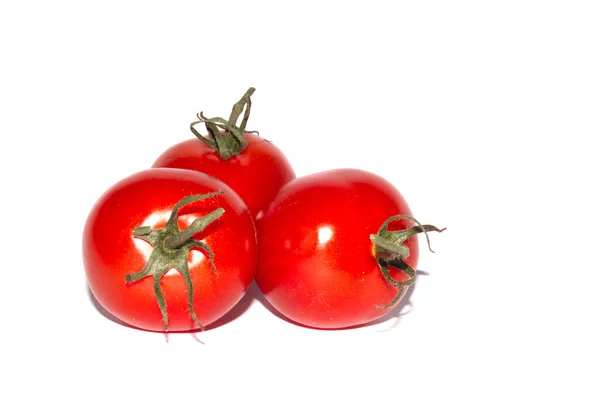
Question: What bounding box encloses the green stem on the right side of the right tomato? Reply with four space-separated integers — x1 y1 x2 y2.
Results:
370 215 446 308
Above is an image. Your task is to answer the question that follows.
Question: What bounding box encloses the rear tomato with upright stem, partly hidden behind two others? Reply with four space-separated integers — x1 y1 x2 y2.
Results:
152 88 296 216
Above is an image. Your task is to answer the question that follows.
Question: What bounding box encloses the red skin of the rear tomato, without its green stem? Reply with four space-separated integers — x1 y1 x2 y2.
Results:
152 133 296 216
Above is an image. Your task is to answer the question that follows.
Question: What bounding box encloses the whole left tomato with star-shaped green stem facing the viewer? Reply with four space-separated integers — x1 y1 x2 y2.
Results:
82 168 257 332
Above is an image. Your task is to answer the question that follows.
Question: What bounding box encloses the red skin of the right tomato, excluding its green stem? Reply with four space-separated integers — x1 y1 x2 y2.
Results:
255 169 419 328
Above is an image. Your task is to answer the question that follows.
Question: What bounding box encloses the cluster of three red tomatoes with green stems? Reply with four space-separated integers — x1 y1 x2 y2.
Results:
83 88 442 331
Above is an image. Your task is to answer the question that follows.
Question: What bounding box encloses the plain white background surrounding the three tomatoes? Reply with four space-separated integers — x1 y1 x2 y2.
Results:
0 0 600 399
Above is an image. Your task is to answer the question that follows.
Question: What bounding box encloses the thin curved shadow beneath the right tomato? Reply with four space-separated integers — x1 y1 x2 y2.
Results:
253 270 429 332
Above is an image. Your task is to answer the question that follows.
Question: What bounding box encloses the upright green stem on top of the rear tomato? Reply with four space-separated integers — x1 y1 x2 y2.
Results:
190 87 256 160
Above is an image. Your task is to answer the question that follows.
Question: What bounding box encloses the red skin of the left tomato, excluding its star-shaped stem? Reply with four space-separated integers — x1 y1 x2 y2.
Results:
83 168 257 331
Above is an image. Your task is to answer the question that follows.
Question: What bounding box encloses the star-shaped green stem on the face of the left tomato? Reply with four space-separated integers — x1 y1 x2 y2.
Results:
125 191 225 331
